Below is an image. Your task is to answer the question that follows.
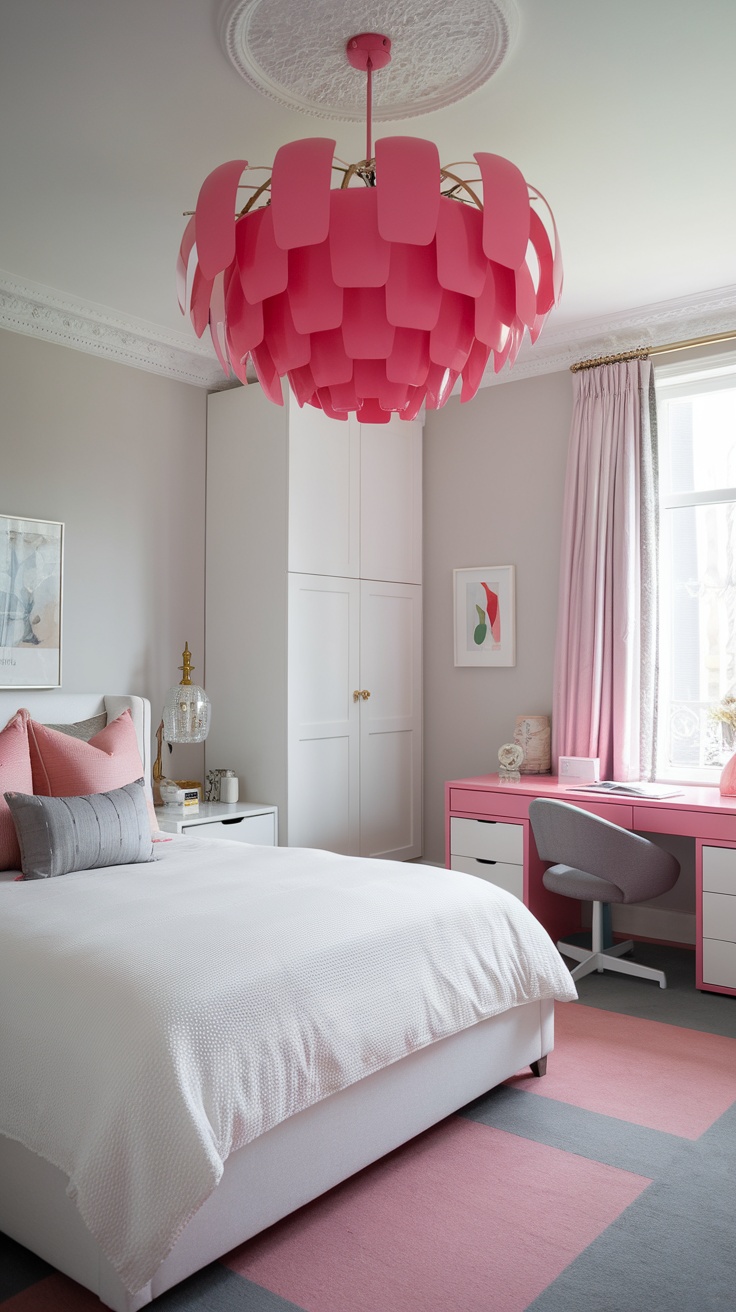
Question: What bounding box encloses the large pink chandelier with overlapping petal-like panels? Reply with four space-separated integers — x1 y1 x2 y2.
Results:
177 33 563 424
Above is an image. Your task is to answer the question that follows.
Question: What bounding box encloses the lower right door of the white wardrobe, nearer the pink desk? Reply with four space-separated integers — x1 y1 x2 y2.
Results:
359 581 422 861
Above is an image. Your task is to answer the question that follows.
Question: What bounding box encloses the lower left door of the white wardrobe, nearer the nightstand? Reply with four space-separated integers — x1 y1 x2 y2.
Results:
286 572 361 855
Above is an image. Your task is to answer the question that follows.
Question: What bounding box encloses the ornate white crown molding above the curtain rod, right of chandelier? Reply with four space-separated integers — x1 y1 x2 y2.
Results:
488 286 736 387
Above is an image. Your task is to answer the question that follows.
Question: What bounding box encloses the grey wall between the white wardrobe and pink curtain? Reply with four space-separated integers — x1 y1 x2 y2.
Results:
424 370 572 862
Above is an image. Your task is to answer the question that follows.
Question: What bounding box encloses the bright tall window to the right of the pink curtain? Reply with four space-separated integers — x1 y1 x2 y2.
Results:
656 356 736 783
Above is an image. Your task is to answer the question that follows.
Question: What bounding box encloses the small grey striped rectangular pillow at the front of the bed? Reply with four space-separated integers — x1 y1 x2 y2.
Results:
4 779 153 879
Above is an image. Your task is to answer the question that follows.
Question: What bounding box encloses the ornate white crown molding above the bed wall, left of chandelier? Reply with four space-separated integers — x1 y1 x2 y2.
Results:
0 270 227 390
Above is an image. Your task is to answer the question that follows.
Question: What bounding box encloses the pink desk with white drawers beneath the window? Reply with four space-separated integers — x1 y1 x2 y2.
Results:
445 774 736 994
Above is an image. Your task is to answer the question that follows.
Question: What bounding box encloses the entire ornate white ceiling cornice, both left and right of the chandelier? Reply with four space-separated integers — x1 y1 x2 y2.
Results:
0 270 736 391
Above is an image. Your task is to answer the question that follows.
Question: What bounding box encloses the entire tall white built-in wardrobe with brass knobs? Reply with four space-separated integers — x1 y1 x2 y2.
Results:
205 384 422 859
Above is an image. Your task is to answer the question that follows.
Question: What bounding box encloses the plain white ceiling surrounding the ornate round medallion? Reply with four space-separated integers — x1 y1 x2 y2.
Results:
0 0 736 383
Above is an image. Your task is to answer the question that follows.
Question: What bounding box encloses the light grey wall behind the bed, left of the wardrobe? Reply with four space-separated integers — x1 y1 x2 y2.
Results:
0 332 206 778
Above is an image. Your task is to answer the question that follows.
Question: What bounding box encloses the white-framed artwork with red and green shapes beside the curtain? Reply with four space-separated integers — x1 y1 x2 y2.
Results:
453 565 516 665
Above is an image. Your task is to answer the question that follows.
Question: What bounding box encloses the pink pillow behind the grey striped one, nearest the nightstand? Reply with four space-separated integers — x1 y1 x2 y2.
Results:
28 711 143 798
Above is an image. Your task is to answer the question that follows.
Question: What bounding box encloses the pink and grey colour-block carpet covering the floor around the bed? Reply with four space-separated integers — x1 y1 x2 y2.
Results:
0 949 736 1312
